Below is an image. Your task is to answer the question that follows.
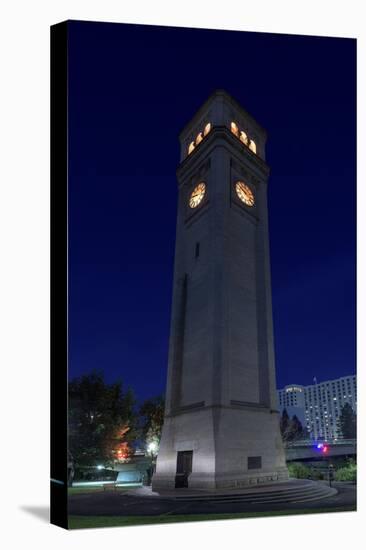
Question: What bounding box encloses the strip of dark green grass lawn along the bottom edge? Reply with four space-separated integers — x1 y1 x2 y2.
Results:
69 506 356 529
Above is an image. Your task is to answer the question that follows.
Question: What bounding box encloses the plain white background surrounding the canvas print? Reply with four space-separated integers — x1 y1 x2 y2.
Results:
0 0 366 549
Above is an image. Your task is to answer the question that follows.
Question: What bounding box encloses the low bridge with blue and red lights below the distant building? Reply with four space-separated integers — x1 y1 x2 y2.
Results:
285 439 357 462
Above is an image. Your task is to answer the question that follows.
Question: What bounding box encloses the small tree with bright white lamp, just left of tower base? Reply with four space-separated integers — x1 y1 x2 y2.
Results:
139 395 164 455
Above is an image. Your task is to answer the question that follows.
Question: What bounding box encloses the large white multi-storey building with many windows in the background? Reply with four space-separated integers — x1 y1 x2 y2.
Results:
277 375 357 439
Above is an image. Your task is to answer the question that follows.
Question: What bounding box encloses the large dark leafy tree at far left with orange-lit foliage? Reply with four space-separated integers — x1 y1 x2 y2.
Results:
69 371 136 466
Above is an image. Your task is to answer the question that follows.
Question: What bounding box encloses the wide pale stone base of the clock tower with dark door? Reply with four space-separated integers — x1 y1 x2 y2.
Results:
152 406 288 492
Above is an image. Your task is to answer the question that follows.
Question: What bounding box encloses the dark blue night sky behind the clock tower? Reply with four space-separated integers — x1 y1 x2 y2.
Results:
69 22 356 406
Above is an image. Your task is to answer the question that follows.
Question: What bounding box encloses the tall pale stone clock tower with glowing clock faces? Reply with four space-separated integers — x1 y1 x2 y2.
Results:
153 90 288 491
